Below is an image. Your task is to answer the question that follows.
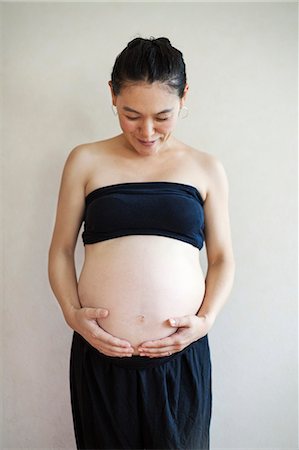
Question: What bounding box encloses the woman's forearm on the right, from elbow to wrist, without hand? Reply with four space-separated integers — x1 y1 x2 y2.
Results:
197 260 235 322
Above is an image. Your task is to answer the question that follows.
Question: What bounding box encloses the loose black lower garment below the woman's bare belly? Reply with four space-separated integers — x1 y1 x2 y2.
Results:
70 332 212 450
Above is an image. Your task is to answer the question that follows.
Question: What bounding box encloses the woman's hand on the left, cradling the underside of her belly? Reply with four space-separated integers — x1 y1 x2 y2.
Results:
66 307 134 357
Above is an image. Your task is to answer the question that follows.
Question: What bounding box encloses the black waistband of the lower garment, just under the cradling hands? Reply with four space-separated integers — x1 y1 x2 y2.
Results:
73 331 208 369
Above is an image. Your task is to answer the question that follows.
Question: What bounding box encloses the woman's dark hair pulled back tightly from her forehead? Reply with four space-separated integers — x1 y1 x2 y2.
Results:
111 37 186 97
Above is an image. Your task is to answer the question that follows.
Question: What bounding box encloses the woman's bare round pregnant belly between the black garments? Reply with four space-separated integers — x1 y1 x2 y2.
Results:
78 235 205 354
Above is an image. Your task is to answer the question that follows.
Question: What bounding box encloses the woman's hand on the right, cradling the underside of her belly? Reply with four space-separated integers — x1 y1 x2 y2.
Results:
138 315 213 358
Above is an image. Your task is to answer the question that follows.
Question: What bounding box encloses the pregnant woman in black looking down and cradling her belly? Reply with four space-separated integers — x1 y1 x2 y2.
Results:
49 37 234 449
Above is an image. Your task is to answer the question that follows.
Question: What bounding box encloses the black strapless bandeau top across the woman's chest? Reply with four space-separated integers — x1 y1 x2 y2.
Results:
82 181 204 253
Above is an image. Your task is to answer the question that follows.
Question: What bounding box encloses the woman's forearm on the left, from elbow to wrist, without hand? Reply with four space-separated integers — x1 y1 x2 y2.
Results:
48 249 81 326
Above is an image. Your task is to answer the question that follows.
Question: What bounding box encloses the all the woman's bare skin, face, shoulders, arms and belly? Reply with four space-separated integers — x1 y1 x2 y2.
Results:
49 81 234 357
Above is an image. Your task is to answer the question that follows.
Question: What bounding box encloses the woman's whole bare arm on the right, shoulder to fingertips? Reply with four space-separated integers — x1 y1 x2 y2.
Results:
140 157 235 357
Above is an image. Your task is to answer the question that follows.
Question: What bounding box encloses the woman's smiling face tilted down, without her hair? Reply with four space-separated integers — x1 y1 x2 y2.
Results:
109 82 188 155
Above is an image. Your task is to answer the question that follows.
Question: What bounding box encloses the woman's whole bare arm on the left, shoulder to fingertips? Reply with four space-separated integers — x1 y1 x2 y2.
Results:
48 146 133 356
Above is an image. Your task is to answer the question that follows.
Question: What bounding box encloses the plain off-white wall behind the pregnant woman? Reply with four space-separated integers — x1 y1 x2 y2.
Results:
0 2 298 450
